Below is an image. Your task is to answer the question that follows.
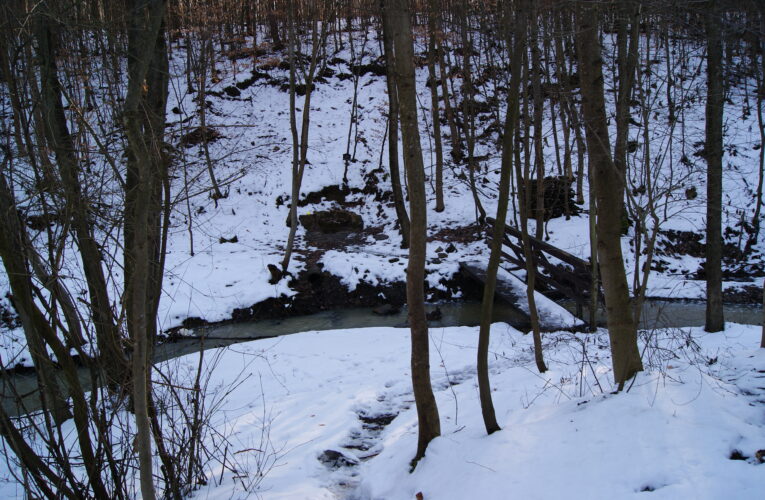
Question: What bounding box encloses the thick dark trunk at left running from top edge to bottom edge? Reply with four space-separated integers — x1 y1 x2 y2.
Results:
123 0 167 500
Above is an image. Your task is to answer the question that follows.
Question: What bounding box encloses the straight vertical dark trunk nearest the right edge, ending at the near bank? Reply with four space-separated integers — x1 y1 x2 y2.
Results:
704 0 725 332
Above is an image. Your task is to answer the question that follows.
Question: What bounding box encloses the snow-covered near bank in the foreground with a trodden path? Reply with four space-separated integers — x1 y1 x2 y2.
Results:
134 323 765 500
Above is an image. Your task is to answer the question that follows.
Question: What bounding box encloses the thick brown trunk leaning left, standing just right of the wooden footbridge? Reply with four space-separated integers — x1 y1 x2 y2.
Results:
576 1 643 390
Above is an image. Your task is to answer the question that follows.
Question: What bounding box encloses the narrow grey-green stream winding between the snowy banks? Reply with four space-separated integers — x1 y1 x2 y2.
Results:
0 300 763 415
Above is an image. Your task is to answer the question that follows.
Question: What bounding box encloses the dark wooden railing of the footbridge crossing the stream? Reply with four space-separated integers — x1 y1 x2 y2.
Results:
486 217 603 318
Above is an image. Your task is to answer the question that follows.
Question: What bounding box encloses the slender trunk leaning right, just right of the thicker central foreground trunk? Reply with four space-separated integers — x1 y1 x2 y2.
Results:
477 0 526 434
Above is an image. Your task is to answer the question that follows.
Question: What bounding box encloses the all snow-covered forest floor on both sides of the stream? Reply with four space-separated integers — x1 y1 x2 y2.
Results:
0 28 765 500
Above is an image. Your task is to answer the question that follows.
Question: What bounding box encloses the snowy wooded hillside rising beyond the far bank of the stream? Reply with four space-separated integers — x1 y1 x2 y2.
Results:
0 29 765 365
